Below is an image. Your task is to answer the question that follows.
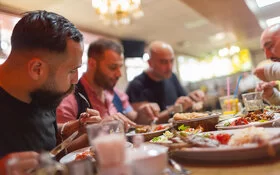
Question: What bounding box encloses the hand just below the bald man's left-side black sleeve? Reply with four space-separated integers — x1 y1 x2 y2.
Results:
137 103 160 123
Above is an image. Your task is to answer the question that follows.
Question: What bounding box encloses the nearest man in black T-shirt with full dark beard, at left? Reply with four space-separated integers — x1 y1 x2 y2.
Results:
0 11 99 174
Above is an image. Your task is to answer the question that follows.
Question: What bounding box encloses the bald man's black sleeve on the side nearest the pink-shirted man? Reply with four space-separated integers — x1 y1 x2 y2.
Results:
126 80 145 103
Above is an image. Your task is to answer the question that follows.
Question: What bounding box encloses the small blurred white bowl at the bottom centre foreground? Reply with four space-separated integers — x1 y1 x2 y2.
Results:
127 143 168 175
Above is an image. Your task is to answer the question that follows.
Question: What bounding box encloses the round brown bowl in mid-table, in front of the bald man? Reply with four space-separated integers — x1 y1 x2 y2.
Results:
172 113 220 131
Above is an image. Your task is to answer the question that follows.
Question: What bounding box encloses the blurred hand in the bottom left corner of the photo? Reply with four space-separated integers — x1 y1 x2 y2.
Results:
0 151 39 175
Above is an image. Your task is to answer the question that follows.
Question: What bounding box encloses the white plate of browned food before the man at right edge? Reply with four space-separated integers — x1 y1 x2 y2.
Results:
216 110 280 130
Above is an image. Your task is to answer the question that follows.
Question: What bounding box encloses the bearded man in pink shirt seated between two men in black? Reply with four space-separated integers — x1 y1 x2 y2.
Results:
57 39 159 125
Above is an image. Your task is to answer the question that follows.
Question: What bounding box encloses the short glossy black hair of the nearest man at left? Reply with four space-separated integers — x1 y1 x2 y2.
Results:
11 10 83 53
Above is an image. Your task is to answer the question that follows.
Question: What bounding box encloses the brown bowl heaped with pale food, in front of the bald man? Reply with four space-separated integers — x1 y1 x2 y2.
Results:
172 112 220 131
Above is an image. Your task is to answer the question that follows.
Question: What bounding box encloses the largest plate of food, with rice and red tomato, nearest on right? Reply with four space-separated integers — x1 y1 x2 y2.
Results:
153 126 280 162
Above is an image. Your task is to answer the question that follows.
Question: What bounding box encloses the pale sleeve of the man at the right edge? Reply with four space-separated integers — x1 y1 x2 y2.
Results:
264 63 280 81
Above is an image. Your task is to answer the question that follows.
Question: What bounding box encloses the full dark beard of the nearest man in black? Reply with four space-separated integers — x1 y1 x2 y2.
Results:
30 84 75 110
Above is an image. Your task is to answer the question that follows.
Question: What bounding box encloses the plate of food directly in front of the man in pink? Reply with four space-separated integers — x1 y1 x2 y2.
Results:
126 123 172 141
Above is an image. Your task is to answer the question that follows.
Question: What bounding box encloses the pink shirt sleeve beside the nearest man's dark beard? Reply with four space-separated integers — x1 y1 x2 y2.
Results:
56 94 78 123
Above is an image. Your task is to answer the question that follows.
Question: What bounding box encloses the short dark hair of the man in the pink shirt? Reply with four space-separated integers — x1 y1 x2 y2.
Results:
88 38 123 58
